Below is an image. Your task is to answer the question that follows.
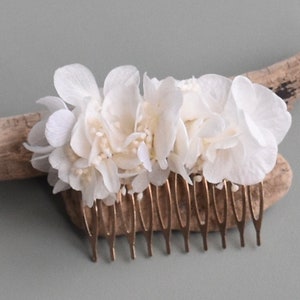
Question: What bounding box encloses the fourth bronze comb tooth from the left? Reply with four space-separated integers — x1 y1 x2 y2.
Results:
136 185 153 256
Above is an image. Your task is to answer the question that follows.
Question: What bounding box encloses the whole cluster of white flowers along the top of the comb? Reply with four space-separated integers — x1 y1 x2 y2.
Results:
25 64 291 206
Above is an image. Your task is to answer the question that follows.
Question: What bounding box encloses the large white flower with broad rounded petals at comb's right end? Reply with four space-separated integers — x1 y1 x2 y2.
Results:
180 75 291 185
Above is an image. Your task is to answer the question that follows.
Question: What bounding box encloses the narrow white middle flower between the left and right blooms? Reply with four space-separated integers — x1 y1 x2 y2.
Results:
132 74 190 193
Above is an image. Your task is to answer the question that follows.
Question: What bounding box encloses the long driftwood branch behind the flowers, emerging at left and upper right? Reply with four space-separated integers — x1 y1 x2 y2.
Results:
0 53 300 181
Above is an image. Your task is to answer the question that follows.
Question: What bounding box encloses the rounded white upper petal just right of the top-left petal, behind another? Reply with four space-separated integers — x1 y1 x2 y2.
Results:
103 66 140 96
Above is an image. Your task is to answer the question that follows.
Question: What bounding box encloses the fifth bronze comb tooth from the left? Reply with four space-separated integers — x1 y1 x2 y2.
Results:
155 180 172 254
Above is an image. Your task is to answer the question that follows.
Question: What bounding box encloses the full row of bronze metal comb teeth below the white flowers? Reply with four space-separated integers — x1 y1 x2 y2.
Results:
82 179 264 261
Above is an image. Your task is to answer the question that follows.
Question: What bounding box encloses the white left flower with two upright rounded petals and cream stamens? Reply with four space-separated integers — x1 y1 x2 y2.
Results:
47 64 141 206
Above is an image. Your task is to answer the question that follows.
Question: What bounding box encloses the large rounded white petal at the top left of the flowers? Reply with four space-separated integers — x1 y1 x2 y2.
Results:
54 64 100 106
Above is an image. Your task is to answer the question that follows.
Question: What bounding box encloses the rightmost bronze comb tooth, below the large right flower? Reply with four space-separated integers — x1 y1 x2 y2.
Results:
247 182 264 246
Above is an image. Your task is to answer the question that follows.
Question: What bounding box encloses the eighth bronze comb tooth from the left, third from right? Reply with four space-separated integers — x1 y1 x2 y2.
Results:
211 180 228 249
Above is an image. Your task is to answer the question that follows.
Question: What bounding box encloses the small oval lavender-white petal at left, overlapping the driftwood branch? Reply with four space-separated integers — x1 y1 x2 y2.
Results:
45 109 75 147
